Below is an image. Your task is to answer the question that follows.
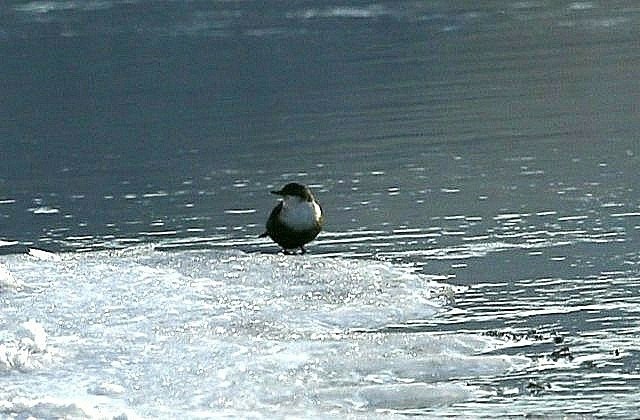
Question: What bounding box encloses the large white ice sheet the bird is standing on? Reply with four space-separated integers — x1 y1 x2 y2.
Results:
0 247 529 418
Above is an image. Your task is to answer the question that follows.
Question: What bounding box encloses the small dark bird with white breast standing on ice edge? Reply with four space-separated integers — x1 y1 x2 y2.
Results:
260 182 324 254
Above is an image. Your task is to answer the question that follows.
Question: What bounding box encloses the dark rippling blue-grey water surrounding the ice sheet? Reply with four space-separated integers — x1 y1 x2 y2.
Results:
0 0 640 417
